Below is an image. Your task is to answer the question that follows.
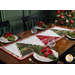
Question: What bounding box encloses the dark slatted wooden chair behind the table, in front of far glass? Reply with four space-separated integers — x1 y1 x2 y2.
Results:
22 15 38 31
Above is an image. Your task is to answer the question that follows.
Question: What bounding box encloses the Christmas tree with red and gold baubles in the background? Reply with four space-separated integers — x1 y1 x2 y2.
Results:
54 10 75 28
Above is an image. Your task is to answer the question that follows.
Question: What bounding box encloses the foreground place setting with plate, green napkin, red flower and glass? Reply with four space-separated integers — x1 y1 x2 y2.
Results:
33 37 58 62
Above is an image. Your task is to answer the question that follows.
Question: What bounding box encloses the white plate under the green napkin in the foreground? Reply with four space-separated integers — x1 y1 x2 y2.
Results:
33 50 58 62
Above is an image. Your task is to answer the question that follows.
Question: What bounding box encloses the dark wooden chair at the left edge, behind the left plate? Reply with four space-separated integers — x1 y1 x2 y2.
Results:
0 20 11 36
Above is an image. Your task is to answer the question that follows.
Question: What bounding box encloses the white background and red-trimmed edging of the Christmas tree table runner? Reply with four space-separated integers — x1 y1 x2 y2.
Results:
0 26 70 60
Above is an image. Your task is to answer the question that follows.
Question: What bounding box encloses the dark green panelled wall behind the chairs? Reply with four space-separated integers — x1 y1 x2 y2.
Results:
0 10 45 34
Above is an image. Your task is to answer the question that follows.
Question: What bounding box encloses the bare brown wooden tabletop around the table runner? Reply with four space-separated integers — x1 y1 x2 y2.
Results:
0 23 75 64
